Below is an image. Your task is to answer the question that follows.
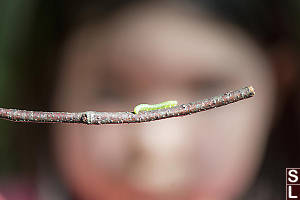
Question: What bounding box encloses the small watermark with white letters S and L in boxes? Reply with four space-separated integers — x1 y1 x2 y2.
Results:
286 168 300 200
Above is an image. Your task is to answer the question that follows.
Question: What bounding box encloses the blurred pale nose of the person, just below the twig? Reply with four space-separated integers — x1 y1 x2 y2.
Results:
129 119 192 191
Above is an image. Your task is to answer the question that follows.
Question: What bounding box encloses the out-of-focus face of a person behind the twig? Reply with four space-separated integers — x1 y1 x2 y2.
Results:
53 1 274 200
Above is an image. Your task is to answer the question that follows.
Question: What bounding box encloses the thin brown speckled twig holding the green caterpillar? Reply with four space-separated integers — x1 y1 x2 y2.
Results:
0 86 255 125
